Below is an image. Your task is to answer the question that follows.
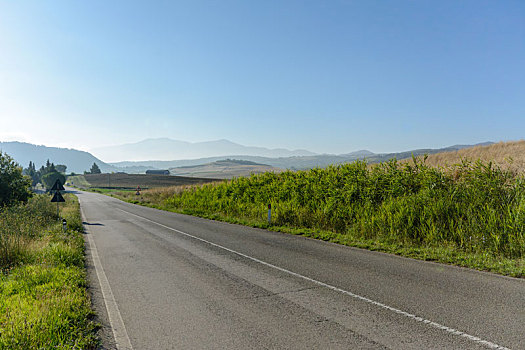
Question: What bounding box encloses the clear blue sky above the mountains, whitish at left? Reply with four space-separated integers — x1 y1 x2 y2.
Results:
0 0 525 153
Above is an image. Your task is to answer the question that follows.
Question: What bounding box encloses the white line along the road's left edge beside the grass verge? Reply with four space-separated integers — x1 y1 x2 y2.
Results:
80 207 133 350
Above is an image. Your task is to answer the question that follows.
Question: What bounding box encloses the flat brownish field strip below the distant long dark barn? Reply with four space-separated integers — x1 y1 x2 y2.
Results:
67 174 217 189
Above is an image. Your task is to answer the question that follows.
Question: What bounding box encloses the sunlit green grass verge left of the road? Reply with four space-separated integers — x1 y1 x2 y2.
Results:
0 194 98 349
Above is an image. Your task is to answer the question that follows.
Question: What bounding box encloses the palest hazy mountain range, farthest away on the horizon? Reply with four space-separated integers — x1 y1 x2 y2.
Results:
91 138 315 161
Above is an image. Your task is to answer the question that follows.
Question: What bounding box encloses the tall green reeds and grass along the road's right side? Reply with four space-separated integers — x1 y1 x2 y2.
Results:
108 160 525 277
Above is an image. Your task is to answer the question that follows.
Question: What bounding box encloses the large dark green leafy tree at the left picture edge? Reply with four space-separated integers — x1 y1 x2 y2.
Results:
0 151 33 208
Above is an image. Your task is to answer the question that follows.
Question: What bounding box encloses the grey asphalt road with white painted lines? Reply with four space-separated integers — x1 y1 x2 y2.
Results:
71 192 525 349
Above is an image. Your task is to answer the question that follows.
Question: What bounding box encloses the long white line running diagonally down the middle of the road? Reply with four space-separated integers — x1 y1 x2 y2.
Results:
116 208 510 350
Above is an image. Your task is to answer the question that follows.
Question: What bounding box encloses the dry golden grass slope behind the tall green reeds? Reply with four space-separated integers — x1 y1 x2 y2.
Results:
408 140 525 174
